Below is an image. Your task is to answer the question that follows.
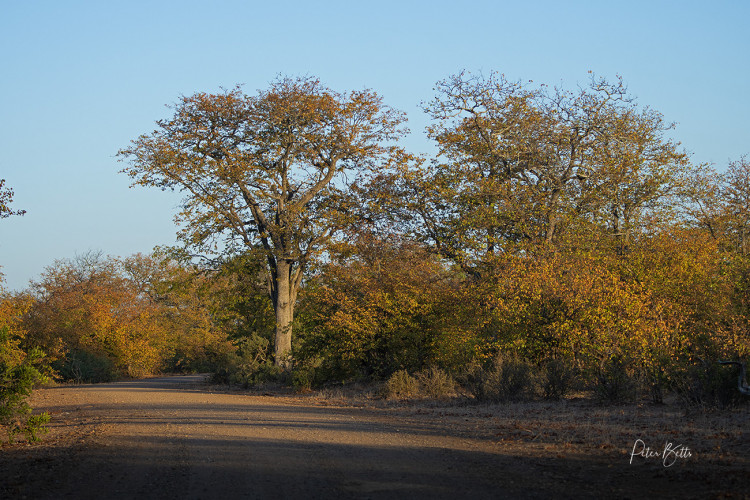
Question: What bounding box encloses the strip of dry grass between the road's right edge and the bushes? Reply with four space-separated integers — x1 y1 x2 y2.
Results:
311 387 750 472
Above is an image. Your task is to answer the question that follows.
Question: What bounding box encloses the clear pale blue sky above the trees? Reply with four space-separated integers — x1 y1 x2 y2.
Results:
0 0 750 290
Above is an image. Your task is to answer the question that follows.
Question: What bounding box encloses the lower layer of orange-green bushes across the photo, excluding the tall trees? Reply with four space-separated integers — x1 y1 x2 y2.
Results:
7 199 750 405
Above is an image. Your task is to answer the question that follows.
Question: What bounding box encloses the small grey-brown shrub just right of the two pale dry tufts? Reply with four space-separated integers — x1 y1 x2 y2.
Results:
462 354 537 402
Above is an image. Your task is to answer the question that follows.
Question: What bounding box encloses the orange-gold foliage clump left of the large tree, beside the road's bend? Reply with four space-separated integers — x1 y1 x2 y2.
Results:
23 253 230 381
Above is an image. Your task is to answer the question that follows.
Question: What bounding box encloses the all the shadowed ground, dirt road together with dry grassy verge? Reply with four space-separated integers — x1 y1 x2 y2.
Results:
0 376 750 499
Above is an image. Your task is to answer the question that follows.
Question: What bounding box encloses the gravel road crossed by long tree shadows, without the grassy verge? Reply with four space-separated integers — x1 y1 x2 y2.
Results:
0 376 741 499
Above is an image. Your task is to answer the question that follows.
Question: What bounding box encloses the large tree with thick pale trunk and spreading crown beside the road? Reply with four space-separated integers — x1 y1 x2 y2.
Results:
119 78 405 366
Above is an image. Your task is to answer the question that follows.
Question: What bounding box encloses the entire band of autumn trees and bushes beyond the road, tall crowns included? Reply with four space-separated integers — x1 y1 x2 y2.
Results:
0 73 750 440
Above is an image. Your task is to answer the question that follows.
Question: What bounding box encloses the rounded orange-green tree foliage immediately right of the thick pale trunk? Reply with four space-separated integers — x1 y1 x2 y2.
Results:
300 236 469 378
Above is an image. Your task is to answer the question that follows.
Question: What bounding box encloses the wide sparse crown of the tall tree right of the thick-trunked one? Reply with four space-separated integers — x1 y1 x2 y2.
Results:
371 73 687 270
